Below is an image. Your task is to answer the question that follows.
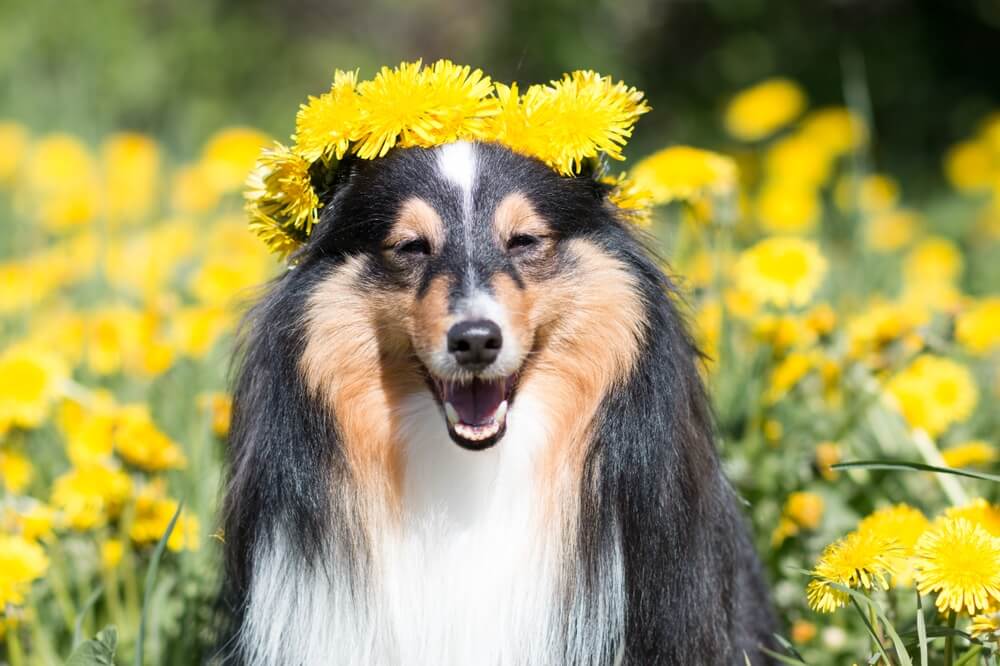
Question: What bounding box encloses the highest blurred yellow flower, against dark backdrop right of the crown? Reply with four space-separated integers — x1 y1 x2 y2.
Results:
725 78 806 141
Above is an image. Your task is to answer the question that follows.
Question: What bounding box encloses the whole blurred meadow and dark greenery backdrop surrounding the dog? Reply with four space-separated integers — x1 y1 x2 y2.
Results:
0 0 1000 666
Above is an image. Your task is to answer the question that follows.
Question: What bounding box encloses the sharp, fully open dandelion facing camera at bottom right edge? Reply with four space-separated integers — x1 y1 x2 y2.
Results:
915 518 1000 615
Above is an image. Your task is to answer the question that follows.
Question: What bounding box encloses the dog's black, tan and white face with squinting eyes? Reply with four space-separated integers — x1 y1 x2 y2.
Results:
296 143 640 450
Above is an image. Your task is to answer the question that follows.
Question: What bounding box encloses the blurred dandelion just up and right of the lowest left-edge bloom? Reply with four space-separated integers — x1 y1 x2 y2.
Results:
52 464 132 530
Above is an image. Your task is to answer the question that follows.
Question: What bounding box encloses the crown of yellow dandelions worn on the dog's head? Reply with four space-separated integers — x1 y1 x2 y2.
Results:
245 60 651 256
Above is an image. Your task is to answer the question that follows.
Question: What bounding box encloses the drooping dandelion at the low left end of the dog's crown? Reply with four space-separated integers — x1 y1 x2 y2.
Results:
244 144 319 256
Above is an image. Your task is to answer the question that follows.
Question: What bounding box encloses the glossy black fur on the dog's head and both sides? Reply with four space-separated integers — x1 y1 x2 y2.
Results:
223 145 772 665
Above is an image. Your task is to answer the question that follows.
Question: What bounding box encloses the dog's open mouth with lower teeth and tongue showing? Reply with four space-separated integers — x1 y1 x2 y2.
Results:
430 375 517 451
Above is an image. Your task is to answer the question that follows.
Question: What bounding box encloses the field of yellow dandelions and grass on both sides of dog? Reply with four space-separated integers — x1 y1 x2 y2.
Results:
0 70 1000 666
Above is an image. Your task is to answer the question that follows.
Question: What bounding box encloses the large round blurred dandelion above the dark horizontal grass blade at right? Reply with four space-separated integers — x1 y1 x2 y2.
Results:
886 354 979 437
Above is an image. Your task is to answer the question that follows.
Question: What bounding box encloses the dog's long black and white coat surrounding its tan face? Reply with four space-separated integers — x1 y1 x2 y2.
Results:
220 140 772 666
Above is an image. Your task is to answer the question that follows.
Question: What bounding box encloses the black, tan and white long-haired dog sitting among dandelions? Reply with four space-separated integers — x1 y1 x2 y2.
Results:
223 142 771 666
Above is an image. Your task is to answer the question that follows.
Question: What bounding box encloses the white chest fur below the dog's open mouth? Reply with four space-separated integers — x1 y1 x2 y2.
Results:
243 393 624 666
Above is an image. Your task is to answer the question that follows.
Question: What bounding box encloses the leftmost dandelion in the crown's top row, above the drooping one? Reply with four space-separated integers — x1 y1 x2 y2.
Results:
292 69 361 162
